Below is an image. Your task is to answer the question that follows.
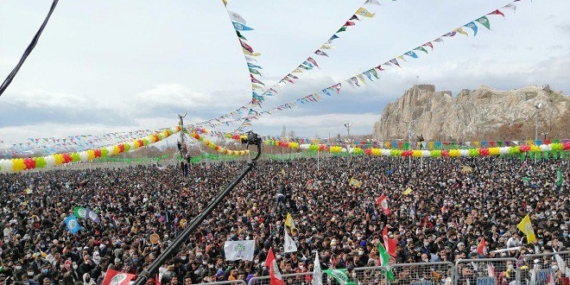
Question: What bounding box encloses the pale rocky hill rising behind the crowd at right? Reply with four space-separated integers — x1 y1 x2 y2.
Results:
374 84 570 140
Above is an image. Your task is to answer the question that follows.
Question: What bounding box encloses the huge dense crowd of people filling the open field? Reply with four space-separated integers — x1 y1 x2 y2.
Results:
0 156 570 285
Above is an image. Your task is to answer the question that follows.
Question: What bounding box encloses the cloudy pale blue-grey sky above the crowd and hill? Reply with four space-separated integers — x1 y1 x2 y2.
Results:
0 0 570 144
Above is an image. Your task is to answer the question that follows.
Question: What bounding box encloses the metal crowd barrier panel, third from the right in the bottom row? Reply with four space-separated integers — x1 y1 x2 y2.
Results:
386 262 455 285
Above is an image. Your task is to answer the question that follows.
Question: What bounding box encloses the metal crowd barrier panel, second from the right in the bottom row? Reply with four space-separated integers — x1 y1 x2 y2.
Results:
455 258 516 285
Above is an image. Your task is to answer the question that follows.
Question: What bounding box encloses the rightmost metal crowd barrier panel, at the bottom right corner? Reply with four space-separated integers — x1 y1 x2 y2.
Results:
519 251 570 285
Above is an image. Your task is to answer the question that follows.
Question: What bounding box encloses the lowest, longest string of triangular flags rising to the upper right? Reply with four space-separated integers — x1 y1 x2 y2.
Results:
205 0 521 132
